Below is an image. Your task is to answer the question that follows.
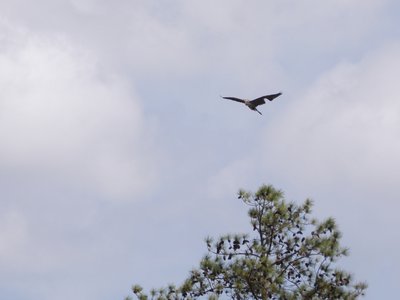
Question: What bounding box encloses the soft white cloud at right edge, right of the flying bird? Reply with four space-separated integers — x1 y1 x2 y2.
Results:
265 44 400 190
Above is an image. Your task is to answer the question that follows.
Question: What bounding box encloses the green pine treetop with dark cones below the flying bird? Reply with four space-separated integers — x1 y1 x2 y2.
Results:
127 185 367 300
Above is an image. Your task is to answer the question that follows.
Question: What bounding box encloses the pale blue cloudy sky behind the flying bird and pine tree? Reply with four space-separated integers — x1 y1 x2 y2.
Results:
0 0 400 300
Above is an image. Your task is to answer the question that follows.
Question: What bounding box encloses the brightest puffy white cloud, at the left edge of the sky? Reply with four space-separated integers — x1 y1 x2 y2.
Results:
0 22 154 198
